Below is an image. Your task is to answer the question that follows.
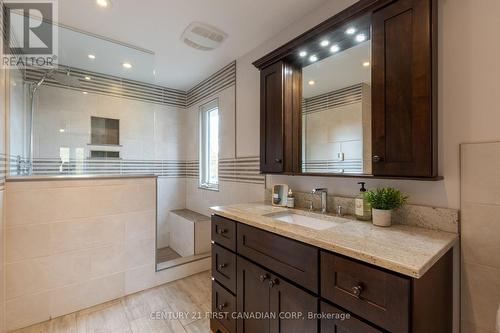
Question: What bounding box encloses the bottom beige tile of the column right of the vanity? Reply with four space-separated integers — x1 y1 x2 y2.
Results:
461 264 500 330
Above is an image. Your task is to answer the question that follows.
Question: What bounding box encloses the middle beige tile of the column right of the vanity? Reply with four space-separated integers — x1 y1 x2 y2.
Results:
462 202 500 268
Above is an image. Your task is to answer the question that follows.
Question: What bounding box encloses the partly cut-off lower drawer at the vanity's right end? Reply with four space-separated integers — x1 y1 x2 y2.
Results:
321 302 383 333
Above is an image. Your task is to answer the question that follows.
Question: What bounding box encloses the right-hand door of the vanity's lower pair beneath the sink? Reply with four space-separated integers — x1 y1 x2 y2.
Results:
269 276 318 333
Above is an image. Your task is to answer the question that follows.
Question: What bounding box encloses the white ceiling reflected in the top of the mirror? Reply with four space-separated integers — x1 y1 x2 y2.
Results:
302 41 371 98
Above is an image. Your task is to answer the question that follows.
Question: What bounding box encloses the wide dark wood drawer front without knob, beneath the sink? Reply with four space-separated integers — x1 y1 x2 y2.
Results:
237 223 319 293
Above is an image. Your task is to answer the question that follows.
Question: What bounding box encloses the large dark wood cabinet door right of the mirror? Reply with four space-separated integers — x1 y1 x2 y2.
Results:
372 0 437 177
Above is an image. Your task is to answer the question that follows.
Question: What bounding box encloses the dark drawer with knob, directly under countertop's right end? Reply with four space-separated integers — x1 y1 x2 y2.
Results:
321 252 410 333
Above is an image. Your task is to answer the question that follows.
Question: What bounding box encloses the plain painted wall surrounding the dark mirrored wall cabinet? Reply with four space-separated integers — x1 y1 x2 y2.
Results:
236 0 500 208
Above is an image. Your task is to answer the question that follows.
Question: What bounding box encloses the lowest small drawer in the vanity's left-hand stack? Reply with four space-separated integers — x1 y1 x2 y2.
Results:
211 281 236 333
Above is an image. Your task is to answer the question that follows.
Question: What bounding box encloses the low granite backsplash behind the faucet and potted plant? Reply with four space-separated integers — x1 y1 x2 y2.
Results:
265 189 459 233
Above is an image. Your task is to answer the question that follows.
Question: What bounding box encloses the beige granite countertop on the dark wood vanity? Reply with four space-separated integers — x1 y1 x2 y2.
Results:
210 203 458 278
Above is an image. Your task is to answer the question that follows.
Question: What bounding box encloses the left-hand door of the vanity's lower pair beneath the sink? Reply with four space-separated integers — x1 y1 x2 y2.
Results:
236 257 271 333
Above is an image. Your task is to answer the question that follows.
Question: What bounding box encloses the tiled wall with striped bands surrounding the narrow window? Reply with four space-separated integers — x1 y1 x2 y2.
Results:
181 63 265 215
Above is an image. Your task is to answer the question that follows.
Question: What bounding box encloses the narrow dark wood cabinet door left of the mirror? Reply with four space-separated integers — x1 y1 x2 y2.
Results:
260 62 284 173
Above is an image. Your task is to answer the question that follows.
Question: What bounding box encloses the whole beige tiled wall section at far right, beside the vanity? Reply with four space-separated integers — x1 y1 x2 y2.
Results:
461 142 500 333
